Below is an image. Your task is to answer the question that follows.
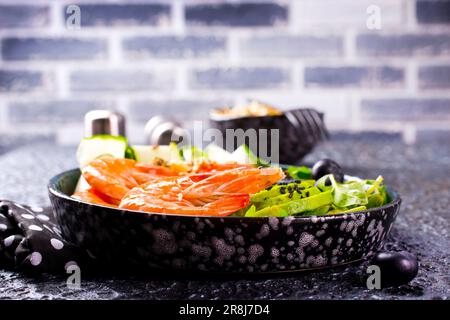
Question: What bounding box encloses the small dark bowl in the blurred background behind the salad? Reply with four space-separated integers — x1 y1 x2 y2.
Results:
209 109 326 163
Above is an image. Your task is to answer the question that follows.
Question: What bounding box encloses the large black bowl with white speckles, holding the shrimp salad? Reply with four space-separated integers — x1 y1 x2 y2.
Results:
49 169 401 272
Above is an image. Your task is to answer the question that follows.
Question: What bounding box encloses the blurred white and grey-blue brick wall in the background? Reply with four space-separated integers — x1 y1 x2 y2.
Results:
0 0 450 143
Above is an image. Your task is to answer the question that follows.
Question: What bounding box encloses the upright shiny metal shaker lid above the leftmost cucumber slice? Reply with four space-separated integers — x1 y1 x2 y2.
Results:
84 110 126 137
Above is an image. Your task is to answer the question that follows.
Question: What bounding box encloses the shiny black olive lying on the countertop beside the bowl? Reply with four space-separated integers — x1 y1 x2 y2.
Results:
371 251 419 288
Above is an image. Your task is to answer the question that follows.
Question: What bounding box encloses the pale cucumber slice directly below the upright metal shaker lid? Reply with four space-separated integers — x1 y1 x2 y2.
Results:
77 135 128 168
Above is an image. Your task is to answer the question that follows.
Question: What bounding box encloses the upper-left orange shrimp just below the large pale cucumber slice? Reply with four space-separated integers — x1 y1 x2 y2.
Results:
81 157 178 202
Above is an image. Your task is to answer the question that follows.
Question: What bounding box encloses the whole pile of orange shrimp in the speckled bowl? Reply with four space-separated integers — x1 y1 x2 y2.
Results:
73 157 284 216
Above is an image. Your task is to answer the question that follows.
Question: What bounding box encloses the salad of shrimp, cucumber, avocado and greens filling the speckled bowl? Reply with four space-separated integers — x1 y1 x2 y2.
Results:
72 135 390 217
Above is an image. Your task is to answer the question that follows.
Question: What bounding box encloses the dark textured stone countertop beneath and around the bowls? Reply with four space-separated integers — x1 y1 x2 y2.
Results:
0 135 450 299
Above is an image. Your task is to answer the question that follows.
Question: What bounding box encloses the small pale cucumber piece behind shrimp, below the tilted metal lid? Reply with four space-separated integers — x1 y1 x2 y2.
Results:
132 142 182 163
